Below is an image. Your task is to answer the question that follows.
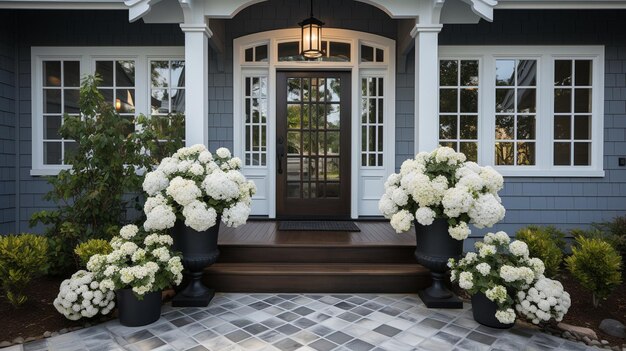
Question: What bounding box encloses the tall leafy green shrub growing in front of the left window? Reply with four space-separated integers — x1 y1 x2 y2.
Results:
31 76 184 274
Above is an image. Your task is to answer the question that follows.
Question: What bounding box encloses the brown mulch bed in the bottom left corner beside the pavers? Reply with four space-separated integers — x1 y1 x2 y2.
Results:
0 277 85 342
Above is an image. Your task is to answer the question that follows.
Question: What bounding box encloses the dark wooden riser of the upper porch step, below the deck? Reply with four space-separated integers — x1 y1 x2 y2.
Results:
218 244 415 263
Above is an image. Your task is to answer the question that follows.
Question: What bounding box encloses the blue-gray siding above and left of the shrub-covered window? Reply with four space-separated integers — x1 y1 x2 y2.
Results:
6 10 184 232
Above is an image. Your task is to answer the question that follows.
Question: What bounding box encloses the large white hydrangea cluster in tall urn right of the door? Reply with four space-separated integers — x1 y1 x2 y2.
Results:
378 147 505 240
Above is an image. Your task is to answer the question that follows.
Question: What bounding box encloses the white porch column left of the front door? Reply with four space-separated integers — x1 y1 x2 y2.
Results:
180 23 212 146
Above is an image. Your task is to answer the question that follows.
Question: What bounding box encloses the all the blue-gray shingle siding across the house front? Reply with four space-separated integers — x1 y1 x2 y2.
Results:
0 5 626 234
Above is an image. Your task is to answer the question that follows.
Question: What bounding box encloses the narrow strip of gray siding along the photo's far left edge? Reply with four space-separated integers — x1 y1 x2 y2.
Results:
0 14 17 235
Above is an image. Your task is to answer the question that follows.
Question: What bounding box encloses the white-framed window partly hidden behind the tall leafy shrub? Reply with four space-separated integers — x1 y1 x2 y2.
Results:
31 47 185 175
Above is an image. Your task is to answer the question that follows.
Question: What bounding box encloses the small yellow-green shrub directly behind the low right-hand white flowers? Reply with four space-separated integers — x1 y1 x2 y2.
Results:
515 225 565 278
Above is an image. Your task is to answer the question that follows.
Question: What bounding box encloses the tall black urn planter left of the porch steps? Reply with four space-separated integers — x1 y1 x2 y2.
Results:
171 217 221 307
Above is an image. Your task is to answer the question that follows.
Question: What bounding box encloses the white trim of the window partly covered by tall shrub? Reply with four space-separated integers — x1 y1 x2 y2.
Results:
30 46 185 176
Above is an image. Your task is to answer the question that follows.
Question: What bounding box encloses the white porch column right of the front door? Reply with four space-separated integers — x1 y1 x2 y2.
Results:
411 24 443 153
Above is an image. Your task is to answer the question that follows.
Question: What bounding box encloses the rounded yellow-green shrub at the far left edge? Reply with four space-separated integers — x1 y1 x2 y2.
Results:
0 234 48 307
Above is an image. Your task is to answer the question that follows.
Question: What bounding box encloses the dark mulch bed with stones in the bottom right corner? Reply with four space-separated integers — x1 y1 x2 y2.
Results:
559 272 626 346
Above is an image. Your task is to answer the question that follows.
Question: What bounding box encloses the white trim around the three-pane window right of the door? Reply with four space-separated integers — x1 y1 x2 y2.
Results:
434 46 605 177
